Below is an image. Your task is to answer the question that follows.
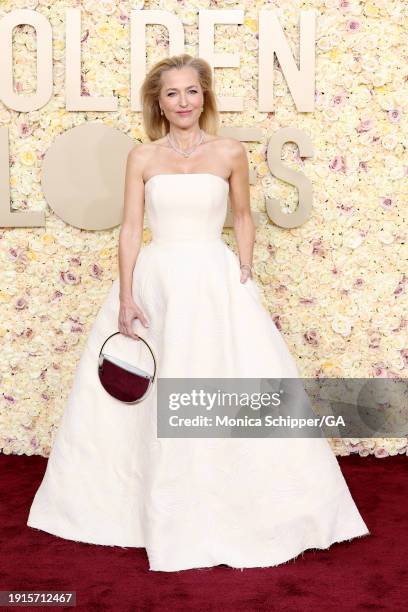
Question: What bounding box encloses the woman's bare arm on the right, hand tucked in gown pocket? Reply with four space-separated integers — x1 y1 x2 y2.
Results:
229 140 255 282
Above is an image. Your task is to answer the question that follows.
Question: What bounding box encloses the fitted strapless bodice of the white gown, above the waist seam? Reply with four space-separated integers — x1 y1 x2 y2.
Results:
145 172 229 244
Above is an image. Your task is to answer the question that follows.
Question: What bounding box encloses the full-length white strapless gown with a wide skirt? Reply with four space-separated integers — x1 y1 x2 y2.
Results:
27 173 369 571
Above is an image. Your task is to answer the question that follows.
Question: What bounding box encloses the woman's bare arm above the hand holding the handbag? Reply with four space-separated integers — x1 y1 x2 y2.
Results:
118 145 144 303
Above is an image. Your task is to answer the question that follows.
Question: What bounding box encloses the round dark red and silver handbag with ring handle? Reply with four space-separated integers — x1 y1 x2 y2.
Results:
98 332 156 404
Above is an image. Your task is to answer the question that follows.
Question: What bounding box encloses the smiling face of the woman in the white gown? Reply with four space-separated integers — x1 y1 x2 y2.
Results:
159 66 204 127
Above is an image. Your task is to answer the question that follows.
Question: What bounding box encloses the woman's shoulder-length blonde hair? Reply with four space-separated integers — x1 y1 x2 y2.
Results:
140 53 219 141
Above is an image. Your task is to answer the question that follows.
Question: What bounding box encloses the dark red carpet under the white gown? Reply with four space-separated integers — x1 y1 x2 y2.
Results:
0 454 408 612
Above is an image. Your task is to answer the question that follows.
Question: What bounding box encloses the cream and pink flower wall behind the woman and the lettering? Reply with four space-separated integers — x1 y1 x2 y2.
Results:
0 0 408 457
